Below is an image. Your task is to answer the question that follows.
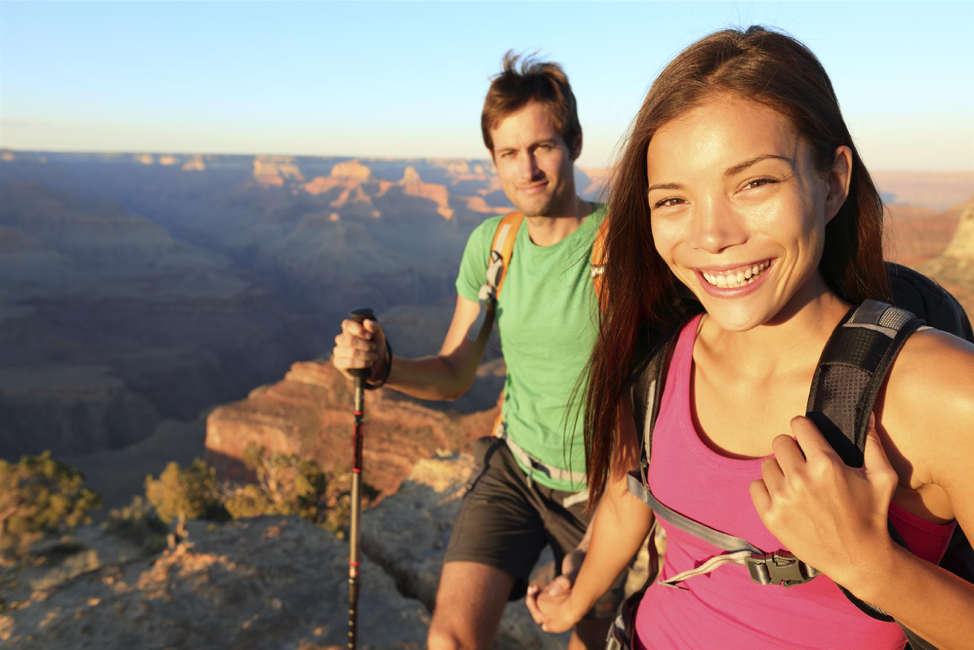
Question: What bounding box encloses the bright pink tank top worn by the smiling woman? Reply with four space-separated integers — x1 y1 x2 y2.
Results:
635 316 955 650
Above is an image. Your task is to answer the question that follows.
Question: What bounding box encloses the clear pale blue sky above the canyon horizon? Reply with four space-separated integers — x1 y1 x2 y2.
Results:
0 1 974 170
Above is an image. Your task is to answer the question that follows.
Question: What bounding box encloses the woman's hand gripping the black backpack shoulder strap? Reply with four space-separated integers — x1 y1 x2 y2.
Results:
751 416 898 592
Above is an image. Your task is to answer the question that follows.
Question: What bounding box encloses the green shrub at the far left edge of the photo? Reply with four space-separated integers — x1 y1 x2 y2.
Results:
0 451 102 555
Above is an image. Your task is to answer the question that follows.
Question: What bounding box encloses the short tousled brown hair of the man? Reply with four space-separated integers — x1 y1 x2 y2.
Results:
480 50 582 156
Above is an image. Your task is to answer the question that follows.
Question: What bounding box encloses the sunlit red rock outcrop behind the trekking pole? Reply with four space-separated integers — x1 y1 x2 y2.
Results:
206 362 496 495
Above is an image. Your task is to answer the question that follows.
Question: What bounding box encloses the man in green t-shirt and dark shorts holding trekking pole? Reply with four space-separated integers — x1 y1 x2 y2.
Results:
333 52 615 649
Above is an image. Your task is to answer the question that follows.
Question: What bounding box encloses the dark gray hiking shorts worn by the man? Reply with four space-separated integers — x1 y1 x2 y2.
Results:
443 437 626 618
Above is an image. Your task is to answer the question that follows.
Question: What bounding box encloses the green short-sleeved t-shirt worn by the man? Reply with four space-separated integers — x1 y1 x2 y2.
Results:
457 206 605 491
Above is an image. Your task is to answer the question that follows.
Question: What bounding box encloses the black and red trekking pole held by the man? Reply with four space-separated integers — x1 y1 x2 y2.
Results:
348 308 375 650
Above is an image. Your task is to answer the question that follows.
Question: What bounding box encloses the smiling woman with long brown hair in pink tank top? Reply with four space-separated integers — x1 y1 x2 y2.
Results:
529 27 974 648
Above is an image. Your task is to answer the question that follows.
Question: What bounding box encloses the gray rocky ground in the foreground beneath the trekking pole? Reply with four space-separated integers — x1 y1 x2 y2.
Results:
0 454 639 650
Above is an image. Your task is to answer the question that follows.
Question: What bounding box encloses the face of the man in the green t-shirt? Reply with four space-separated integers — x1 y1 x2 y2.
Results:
490 102 581 217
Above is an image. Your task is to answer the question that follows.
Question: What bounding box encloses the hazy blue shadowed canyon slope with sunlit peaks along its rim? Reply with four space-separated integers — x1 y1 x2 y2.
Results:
0 151 532 458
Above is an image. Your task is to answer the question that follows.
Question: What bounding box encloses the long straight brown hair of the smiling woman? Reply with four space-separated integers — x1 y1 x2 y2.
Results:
584 26 889 506
